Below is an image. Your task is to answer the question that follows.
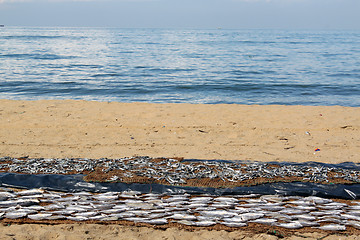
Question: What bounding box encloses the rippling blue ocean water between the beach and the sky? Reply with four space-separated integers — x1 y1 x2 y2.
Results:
0 27 360 107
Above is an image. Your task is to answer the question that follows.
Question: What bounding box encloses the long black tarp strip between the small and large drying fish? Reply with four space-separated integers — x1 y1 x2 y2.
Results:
0 173 360 199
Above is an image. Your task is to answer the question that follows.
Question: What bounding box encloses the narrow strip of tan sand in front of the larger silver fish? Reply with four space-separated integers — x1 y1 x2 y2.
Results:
0 224 360 240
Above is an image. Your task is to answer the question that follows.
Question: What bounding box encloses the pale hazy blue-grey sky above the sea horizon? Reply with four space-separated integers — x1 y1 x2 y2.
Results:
0 0 360 30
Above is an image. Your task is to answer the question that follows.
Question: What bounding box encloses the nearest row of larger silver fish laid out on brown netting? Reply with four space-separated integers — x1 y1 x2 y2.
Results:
0 188 360 231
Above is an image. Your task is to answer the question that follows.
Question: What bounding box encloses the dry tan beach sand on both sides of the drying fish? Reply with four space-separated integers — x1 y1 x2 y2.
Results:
0 100 360 239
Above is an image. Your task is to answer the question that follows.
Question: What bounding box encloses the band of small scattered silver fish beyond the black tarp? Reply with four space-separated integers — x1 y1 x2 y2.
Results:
0 157 360 185
